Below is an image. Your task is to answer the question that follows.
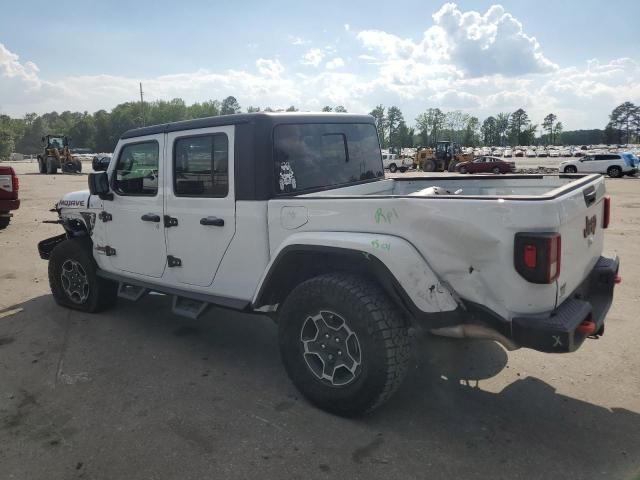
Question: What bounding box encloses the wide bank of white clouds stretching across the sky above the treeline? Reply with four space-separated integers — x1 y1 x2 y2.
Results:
0 4 640 129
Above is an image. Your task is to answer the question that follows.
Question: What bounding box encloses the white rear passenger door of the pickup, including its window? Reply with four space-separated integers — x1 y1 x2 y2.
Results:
165 126 236 287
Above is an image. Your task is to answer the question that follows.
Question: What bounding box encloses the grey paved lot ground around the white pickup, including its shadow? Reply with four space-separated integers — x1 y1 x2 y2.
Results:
0 159 640 480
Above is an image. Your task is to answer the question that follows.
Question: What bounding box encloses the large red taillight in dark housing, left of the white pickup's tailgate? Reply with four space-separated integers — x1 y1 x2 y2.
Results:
513 233 562 284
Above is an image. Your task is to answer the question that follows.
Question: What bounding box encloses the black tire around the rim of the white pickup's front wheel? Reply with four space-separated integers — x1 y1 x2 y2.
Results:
49 237 118 313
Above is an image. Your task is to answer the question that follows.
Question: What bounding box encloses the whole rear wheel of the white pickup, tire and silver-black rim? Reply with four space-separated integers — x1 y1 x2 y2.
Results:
278 273 410 416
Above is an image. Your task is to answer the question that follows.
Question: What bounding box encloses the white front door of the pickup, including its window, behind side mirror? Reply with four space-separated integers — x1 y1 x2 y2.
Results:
105 134 167 277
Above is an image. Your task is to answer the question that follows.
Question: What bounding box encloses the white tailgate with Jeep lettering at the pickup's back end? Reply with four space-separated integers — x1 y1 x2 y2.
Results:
556 177 605 305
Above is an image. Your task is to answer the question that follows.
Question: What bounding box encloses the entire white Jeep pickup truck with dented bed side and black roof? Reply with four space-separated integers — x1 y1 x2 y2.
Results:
39 113 619 415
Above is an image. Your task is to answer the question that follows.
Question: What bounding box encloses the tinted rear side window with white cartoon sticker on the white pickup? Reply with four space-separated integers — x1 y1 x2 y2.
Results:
273 123 384 193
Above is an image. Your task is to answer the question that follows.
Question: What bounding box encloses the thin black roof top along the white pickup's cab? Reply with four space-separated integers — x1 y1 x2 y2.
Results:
120 112 374 138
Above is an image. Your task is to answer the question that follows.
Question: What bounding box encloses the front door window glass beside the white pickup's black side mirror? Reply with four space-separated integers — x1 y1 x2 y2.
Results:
113 140 159 196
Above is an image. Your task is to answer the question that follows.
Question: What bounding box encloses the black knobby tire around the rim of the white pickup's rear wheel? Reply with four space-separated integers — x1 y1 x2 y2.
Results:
278 273 411 416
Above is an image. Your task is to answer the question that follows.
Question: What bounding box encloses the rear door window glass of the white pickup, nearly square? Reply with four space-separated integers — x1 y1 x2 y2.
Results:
173 134 229 198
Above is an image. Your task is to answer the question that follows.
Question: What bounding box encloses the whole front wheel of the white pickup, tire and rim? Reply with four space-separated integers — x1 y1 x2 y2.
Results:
49 238 118 313
